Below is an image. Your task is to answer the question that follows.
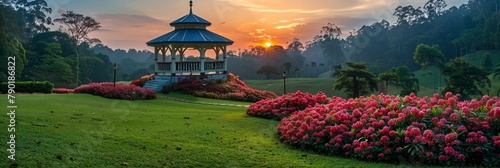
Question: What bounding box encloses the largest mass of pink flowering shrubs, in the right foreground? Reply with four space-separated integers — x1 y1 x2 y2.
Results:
277 93 500 167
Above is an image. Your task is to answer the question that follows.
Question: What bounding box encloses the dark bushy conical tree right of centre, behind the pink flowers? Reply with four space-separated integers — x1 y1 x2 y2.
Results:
333 62 378 98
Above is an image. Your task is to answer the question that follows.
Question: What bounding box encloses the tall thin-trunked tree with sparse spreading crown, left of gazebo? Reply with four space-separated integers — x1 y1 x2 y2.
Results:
54 11 101 86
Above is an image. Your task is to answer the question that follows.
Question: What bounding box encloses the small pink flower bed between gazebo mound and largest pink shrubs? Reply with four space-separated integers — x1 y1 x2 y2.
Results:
247 91 328 120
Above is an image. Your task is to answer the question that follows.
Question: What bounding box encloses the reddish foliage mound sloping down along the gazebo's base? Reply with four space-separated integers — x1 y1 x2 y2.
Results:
170 73 277 102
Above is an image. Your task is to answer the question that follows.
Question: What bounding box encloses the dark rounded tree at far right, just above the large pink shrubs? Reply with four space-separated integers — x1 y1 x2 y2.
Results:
443 58 491 100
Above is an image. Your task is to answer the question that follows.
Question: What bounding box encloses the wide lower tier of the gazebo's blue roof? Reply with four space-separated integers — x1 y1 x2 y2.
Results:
147 29 234 45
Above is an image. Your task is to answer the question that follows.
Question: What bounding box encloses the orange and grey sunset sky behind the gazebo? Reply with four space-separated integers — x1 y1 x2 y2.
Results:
47 0 468 50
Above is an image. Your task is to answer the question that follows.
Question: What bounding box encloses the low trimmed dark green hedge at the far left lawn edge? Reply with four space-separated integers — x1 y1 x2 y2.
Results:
1 81 54 93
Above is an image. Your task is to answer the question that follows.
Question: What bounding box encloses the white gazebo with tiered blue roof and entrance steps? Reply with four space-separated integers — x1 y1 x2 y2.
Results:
145 0 234 91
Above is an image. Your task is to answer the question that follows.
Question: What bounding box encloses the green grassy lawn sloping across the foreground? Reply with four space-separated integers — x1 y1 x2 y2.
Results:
0 94 410 167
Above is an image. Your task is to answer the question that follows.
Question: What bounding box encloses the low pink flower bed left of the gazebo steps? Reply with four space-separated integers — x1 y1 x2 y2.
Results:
74 83 156 100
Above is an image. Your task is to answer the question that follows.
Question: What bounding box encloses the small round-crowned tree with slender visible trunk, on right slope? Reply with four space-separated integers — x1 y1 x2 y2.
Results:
413 43 445 93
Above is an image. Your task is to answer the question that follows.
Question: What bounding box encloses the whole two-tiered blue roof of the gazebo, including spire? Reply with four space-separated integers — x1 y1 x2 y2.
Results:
146 1 234 46
